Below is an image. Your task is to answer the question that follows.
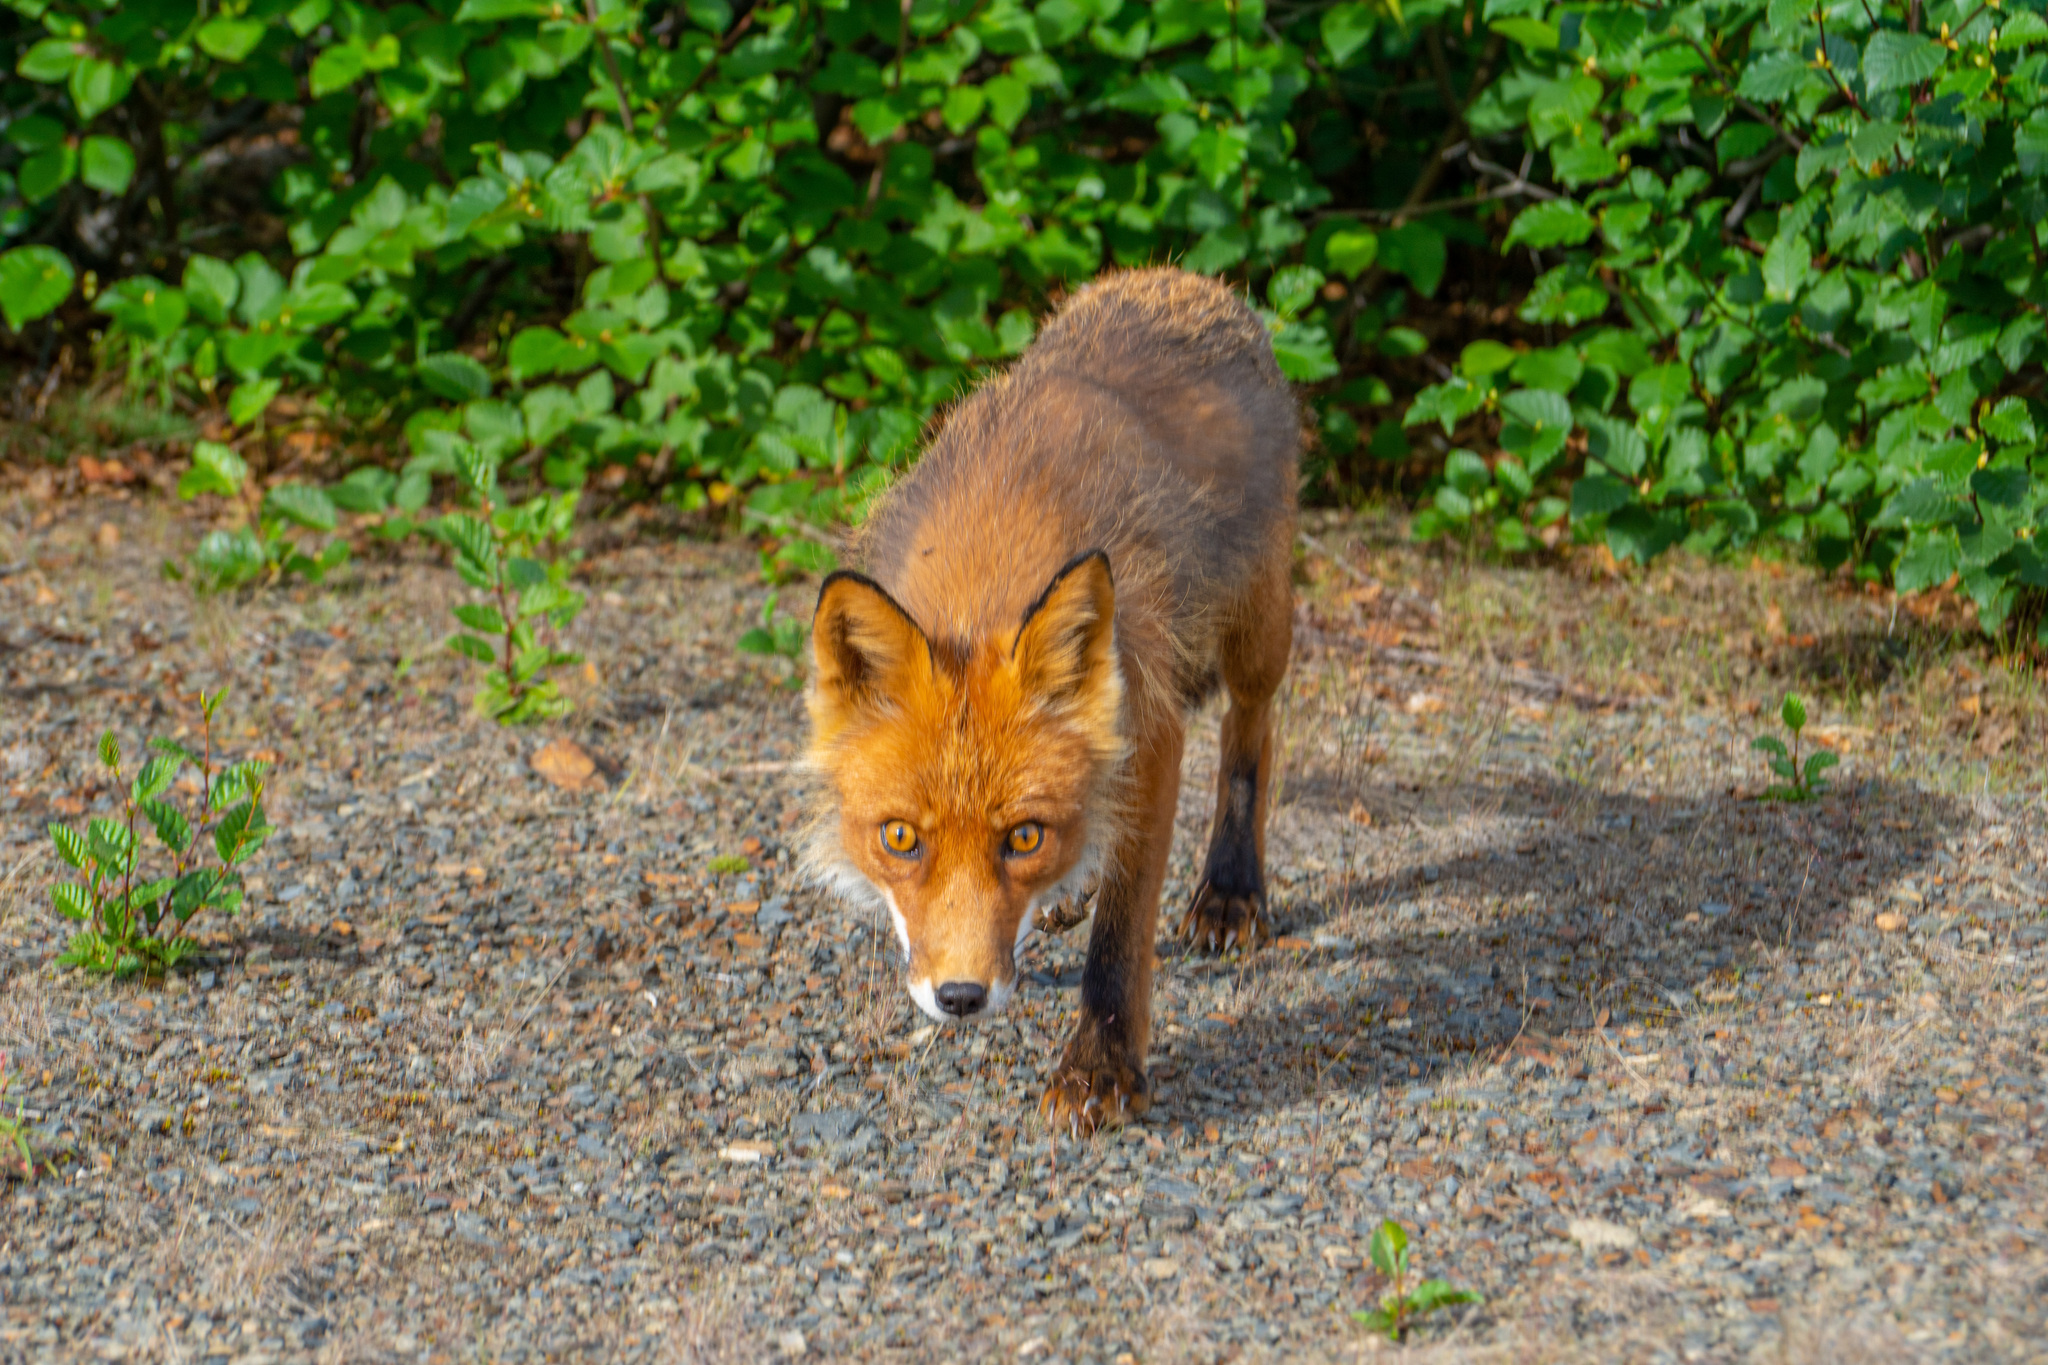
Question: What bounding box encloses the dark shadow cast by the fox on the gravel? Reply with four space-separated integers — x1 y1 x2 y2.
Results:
1155 780 1968 1124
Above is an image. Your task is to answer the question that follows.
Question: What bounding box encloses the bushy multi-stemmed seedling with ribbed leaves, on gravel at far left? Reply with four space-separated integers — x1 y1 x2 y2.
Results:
49 688 270 976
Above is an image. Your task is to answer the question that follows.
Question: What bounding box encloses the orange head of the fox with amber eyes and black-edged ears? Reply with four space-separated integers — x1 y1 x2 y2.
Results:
807 551 1124 1021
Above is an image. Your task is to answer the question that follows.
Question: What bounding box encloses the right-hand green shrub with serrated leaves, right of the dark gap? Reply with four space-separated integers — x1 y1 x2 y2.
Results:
1407 0 2048 641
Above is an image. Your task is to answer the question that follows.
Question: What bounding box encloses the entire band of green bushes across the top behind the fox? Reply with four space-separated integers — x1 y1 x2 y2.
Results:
12 0 2048 645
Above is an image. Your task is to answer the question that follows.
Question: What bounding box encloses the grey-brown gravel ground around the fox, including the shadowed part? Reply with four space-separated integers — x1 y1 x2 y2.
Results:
0 485 2048 1365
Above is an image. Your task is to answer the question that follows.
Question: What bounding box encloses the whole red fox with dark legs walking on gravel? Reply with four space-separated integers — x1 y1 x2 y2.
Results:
807 270 1300 1134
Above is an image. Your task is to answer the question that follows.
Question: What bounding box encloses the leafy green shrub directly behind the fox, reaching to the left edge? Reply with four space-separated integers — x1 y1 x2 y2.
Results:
0 0 1497 544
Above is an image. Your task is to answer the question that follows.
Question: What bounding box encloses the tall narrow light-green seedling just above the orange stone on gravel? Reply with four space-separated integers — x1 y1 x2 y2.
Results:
434 446 584 724
